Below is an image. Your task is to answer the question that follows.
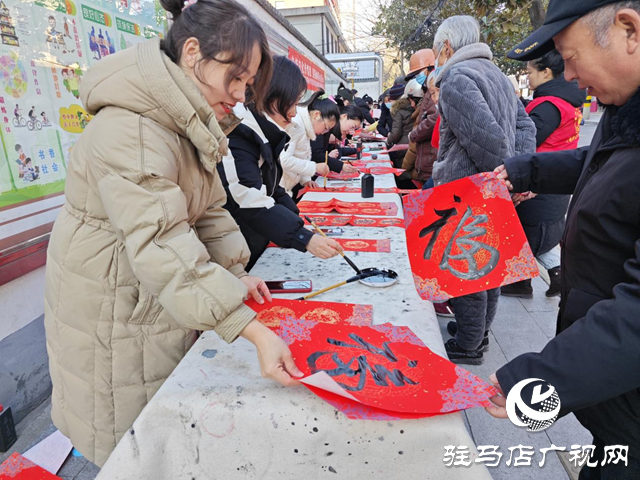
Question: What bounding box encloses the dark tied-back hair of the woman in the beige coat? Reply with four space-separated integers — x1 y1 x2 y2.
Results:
160 0 272 111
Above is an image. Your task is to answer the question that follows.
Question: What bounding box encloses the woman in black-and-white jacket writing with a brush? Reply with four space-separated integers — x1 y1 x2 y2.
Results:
218 56 340 268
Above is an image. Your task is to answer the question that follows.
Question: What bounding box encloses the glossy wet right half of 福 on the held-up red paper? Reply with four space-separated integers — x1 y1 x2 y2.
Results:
440 207 500 280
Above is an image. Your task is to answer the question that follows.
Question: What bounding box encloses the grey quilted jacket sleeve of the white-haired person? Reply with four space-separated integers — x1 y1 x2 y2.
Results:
439 74 512 172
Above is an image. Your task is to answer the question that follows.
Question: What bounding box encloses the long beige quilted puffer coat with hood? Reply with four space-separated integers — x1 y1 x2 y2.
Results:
45 41 255 466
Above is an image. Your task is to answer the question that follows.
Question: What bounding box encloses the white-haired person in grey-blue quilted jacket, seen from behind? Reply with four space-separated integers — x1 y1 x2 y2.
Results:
432 16 536 365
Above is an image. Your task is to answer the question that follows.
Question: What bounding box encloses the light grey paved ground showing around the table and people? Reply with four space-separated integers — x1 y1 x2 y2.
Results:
0 114 600 480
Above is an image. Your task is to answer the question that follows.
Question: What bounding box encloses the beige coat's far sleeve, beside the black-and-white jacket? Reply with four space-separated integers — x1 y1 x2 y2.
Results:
195 175 251 278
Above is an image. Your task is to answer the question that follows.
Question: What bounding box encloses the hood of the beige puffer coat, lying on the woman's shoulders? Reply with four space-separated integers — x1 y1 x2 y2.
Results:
80 39 240 170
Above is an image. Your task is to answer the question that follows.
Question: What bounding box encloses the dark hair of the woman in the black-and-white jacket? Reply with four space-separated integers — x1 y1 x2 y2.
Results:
264 55 307 121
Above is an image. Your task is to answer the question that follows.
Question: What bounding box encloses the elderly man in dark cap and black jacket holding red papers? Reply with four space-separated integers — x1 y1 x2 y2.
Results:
488 0 640 480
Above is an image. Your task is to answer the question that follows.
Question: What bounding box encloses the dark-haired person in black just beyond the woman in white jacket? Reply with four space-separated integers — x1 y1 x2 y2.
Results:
311 104 364 173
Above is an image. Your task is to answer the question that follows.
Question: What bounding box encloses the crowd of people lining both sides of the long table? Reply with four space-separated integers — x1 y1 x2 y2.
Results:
40 0 640 478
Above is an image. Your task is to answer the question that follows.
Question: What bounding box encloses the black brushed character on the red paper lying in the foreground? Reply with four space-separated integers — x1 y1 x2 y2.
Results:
307 333 418 392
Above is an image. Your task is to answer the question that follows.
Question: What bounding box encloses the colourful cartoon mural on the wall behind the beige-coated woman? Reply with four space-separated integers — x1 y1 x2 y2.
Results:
0 0 166 212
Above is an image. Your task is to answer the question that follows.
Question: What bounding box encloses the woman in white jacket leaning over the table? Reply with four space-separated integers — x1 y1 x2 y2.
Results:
280 90 340 195
